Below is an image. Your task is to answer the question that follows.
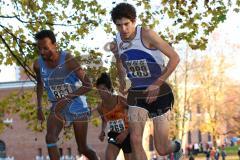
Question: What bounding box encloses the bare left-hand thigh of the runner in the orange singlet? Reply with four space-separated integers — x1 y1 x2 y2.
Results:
104 143 120 160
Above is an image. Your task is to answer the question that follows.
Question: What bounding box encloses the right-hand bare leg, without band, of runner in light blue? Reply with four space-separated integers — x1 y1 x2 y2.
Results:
73 118 98 160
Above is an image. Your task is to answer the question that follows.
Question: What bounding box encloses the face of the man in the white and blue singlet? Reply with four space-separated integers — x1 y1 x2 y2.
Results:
116 18 136 39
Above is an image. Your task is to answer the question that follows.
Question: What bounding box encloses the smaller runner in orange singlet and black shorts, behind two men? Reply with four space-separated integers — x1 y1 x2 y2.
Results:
96 73 132 160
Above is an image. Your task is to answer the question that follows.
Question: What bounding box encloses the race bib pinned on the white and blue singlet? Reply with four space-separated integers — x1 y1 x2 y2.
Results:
126 59 151 78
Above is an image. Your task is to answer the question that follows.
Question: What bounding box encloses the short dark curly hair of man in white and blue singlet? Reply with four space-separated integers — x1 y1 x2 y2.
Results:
111 3 137 24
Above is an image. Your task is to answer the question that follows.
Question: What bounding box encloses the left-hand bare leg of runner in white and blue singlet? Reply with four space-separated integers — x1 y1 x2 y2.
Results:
128 106 148 160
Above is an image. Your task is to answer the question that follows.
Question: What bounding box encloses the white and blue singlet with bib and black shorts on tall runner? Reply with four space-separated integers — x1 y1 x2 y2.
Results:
116 26 174 118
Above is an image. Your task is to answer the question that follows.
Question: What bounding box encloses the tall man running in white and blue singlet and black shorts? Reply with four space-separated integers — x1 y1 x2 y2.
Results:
110 3 182 160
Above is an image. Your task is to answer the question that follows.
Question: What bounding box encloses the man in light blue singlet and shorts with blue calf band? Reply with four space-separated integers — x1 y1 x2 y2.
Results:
34 30 98 160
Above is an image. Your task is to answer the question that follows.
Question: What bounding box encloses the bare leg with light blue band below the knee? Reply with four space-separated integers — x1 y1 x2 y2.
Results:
46 113 63 160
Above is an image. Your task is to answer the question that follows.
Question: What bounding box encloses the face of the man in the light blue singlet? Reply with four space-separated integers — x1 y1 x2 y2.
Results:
37 37 57 60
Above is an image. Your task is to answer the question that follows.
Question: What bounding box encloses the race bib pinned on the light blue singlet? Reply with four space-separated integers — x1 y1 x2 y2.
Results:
50 84 73 99
